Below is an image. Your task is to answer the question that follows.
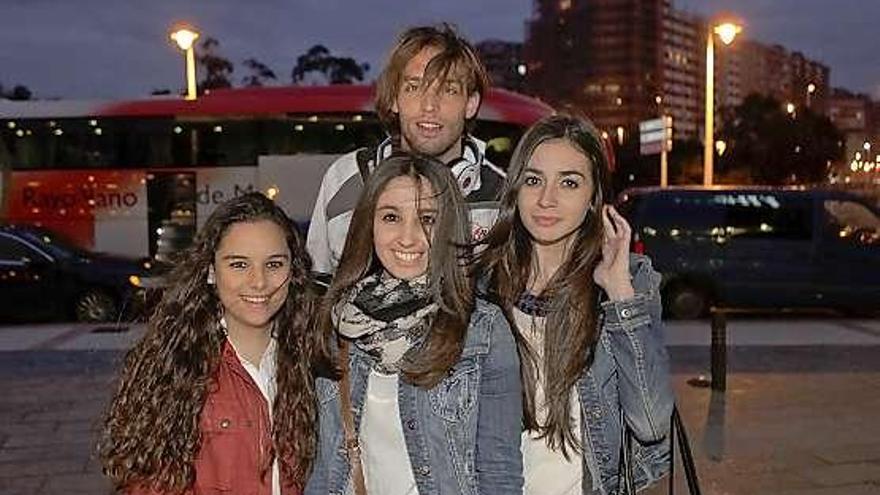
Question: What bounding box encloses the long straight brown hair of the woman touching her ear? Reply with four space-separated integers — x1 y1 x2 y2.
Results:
475 115 608 456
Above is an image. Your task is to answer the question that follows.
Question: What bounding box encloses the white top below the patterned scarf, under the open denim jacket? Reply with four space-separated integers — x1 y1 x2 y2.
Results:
360 370 419 495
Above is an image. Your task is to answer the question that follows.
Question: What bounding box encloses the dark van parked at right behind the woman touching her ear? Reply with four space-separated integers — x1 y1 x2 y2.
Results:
620 187 880 318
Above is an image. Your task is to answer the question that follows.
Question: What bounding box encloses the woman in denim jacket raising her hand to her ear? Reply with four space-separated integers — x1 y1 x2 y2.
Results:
476 116 673 495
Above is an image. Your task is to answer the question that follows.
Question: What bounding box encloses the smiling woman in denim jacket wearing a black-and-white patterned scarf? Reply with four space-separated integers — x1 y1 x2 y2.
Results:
306 155 522 495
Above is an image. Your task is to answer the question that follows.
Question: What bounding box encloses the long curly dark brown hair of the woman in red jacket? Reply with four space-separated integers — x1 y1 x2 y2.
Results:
99 193 329 492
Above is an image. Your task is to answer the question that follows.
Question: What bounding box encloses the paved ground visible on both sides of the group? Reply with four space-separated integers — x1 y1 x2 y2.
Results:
0 320 880 495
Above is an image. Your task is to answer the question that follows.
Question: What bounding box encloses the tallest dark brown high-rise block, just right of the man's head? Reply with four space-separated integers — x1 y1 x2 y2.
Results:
524 0 669 137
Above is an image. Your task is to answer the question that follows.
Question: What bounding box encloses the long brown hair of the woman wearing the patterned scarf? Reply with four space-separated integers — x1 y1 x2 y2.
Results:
320 153 474 387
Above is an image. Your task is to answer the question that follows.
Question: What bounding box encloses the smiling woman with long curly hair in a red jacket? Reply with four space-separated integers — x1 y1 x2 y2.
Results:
100 193 327 495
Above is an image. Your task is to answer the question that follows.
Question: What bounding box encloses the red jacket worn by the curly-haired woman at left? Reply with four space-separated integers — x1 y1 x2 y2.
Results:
128 341 301 495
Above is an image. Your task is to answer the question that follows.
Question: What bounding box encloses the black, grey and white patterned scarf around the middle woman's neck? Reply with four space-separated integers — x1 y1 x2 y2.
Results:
332 271 437 374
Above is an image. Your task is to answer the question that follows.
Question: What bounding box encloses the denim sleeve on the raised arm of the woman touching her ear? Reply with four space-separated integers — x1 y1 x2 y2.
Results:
600 255 674 443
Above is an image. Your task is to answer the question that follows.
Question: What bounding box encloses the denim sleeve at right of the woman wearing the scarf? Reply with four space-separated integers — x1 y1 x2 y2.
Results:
475 307 523 495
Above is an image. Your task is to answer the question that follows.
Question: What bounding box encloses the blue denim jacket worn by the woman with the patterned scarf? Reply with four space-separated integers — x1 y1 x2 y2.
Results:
305 299 523 495
